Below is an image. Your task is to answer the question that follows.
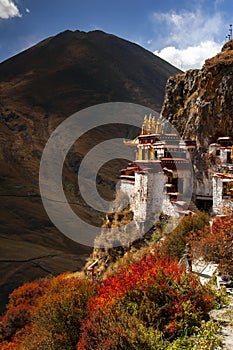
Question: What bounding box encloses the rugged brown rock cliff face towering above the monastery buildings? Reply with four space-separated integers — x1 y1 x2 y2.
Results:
162 40 233 149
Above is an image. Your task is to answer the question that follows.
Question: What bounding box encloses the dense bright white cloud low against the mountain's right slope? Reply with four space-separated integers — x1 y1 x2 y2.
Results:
154 40 222 71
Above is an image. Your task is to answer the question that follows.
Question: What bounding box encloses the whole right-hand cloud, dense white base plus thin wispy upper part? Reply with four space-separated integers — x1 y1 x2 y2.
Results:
153 9 224 70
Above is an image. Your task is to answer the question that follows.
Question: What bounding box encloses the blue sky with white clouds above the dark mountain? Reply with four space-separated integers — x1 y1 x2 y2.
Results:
0 0 233 70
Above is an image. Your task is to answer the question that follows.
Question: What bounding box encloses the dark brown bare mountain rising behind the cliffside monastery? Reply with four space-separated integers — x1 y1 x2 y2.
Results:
0 31 179 307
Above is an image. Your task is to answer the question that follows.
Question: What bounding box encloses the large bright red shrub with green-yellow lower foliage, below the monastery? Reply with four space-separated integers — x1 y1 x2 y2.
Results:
77 254 213 350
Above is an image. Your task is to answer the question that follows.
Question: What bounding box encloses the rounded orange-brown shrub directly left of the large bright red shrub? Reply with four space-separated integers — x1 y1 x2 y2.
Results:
23 274 94 350
